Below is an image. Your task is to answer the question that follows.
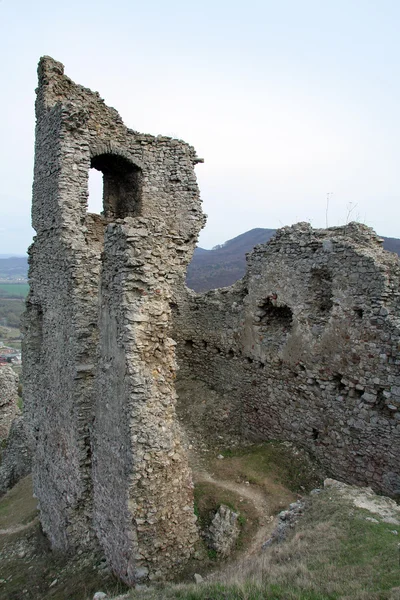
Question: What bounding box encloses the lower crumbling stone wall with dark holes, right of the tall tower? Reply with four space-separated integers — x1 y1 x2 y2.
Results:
174 223 400 494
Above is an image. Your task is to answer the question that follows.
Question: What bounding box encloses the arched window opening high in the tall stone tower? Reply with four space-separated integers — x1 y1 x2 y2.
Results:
89 154 142 219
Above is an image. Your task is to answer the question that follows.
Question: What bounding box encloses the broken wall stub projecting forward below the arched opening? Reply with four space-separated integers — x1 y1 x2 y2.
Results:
94 218 197 583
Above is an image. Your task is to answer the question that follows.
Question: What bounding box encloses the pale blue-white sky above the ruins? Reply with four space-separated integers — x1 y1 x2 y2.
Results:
0 0 400 254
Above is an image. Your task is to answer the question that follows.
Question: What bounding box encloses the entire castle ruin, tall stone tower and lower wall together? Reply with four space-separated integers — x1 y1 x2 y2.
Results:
23 57 400 584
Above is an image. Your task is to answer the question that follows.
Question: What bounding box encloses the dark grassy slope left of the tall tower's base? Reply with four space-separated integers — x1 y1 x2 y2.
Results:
0 477 127 600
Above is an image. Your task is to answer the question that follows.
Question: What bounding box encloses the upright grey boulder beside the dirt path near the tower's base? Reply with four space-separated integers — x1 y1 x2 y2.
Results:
206 504 240 557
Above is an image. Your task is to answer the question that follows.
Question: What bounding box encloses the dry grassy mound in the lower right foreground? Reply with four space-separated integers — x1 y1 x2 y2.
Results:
126 489 400 600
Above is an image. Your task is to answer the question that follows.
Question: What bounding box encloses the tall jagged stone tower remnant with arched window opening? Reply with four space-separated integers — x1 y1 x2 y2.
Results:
23 57 204 584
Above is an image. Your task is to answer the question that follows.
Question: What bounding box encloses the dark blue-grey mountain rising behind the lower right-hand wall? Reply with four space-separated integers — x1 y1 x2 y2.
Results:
186 228 400 292
